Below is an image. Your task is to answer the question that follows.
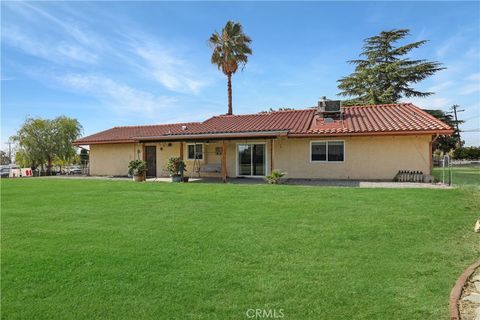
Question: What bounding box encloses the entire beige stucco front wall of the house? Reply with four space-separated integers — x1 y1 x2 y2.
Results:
90 135 431 180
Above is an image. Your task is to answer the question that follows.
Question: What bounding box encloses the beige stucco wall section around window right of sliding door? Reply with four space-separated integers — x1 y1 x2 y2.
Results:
273 135 431 180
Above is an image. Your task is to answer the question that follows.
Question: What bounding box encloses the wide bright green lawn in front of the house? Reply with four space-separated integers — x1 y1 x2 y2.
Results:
1 179 480 320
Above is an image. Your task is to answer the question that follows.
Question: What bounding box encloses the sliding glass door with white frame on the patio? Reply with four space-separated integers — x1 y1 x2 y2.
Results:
237 143 266 176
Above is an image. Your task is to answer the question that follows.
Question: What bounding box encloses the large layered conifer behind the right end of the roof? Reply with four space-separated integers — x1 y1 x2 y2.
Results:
338 29 444 105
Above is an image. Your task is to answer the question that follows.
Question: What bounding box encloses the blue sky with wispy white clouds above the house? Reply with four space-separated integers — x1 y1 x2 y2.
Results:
0 2 480 149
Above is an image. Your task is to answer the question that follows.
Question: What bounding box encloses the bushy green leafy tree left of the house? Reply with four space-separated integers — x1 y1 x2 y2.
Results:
12 116 82 172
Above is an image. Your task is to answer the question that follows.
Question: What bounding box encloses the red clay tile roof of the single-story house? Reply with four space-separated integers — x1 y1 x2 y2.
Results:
75 103 452 145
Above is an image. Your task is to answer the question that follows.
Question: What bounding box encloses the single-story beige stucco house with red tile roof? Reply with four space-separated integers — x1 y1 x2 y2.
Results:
75 101 452 180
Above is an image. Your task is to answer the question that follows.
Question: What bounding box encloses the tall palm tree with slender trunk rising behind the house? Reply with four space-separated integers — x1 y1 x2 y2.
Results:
209 21 252 114
